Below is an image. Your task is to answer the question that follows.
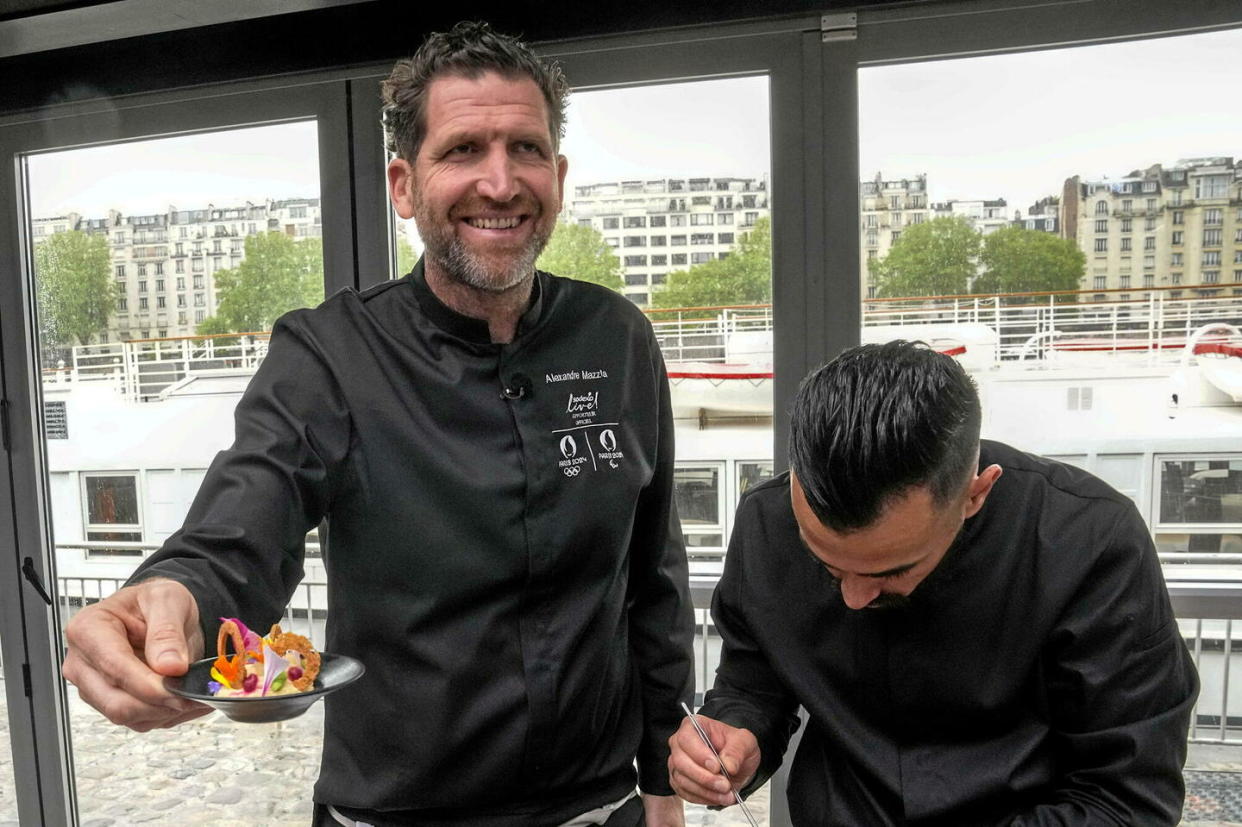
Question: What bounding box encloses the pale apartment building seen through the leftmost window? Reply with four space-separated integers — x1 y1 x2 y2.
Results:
32 199 323 341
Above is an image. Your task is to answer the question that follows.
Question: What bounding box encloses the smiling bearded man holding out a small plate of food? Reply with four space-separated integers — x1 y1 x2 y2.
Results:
65 24 693 827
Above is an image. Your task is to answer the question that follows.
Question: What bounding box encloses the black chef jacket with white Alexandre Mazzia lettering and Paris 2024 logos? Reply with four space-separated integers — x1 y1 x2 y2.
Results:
134 262 693 827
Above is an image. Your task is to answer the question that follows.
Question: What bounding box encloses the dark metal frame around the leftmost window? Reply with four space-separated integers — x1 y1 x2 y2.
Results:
0 73 362 823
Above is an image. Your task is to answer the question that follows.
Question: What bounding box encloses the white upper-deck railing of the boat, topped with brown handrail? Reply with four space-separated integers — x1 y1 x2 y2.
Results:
43 289 1242 401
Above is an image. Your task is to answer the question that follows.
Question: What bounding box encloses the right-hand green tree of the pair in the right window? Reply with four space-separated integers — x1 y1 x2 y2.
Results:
974 227 1087 293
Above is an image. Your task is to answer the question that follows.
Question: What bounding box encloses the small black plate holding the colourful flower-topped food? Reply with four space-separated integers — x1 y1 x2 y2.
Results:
164 652 366 724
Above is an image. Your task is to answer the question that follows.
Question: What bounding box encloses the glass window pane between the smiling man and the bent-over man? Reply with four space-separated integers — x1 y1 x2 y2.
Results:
539 76 773 574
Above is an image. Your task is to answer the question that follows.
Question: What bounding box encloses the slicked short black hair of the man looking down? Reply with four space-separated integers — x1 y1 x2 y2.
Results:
789 340 982 533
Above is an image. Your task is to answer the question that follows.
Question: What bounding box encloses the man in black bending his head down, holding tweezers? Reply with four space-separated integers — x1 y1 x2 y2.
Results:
669 341 1199 827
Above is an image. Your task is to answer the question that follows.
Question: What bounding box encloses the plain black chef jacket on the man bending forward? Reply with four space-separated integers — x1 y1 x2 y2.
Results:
703 441 1199 827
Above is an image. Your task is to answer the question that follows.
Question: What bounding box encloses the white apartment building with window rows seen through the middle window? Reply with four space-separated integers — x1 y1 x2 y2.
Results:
565 178 769 307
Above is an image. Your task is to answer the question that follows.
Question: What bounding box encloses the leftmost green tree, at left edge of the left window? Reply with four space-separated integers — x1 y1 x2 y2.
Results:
35 230 117 356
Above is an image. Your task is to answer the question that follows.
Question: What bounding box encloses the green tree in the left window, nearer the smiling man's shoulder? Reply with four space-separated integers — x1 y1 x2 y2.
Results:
196 232 323 333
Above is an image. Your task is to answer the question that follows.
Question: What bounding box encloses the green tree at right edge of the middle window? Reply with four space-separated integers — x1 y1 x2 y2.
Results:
652 216 773 307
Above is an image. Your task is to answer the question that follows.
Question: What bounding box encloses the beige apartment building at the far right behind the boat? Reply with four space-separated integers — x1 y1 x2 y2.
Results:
1061 156 1242 298
